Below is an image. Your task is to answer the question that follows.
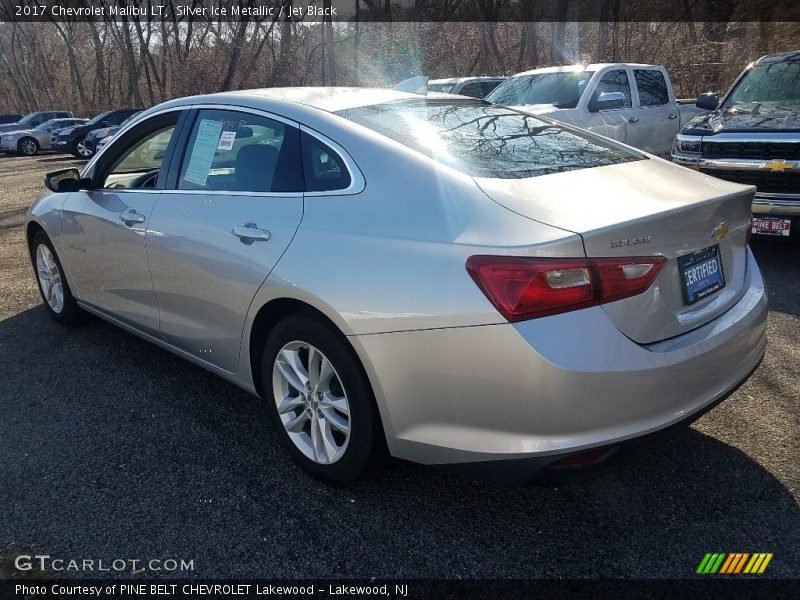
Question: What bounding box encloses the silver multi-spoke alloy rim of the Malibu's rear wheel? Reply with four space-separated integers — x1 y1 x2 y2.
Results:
272 341 351 465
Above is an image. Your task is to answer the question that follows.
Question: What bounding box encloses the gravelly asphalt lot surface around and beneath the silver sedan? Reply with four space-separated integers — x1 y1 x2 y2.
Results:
0 155 800 578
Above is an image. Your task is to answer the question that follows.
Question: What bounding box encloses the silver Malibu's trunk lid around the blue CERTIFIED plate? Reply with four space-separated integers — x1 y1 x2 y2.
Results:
476 159 755 344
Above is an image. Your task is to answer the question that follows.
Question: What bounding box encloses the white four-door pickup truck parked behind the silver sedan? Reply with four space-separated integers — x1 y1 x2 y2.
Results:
486 63 707 156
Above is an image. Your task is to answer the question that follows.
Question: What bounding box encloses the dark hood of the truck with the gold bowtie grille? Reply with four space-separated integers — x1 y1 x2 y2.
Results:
686 104 800 135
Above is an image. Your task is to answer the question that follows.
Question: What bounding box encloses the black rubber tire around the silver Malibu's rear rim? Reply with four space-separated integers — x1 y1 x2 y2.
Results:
261 313 387 486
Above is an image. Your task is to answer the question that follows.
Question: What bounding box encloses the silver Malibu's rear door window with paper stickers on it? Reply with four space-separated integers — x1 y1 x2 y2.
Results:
178 109 303 192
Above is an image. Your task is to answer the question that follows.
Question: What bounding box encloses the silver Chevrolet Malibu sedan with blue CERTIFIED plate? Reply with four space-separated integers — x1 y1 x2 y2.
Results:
27 88 766 485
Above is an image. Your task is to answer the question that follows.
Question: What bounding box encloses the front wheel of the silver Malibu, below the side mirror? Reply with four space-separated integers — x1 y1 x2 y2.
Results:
31 231 86 325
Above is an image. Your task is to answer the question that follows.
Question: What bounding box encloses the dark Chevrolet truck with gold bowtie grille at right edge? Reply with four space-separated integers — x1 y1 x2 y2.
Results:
672 51 800 238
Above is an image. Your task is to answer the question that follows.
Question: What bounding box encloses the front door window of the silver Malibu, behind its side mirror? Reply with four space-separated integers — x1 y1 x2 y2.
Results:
100 113 178 189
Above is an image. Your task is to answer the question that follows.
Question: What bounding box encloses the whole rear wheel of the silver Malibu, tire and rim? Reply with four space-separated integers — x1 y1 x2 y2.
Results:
262 314 385 486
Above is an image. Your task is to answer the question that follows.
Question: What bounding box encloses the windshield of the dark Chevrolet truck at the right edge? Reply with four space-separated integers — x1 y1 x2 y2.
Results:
723 61 800 111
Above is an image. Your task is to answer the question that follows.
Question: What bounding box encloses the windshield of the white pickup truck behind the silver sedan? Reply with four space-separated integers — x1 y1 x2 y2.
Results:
486 71 594 108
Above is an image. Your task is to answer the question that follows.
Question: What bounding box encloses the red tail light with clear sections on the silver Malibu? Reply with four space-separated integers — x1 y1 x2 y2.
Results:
467 256 667 322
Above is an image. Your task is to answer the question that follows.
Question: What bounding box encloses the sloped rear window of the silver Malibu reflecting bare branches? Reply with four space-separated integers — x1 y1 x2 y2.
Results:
337 99 639 179
